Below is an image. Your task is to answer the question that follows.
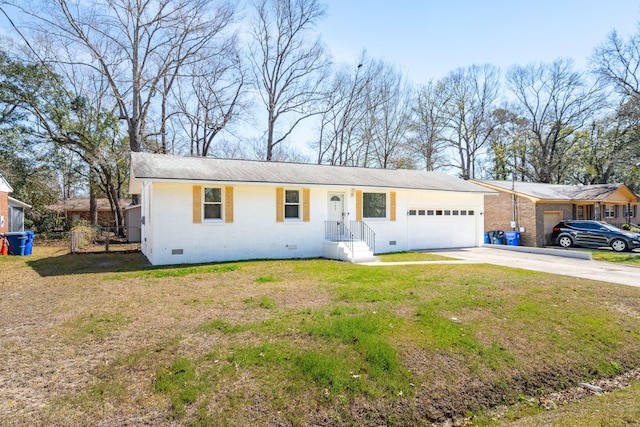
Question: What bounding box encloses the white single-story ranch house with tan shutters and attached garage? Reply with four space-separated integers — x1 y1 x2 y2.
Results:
129 153 495 265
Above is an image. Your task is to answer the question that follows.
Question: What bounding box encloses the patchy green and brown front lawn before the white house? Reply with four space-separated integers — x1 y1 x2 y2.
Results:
0 247 640 426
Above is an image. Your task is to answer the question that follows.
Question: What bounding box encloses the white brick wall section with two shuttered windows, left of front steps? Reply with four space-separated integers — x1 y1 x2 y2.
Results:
148 183 326 264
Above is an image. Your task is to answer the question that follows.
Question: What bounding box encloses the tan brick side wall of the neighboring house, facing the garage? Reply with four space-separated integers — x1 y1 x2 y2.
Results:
484 191 536 246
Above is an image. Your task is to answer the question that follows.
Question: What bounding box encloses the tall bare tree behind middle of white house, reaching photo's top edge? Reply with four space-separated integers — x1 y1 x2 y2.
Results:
250 0 329 161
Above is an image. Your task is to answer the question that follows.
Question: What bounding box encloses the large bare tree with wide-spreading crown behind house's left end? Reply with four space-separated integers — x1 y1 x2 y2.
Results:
14 0 235 151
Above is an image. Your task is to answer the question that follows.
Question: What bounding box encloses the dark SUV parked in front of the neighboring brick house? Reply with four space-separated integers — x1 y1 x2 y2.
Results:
551 220 640 252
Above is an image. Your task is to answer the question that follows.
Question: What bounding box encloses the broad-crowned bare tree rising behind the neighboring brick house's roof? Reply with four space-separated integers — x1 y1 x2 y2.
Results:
507 59 602 183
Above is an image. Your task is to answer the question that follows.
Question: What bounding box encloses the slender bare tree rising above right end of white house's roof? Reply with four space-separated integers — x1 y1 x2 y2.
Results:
442 64 500 179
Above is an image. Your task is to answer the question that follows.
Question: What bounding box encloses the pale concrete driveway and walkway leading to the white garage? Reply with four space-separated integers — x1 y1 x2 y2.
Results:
366 246 640 287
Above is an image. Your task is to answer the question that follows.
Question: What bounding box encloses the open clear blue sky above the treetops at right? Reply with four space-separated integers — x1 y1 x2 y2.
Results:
318 0 640 83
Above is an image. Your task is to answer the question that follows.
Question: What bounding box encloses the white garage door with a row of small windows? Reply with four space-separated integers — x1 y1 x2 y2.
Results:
407 208 478 250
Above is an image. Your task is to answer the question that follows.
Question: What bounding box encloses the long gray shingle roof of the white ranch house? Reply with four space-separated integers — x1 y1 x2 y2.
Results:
131 153 494 194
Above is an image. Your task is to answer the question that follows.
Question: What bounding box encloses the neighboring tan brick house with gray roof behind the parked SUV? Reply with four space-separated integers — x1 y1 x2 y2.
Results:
471 180 640 247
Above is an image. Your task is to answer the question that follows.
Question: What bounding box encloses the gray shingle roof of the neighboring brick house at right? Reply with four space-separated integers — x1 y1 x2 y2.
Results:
477 180 636 201
